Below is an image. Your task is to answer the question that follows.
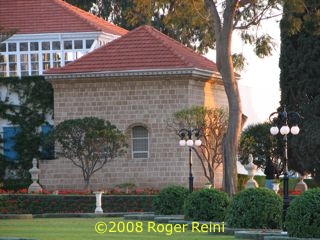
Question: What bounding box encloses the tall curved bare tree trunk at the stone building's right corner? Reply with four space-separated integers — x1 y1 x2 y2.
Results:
216 1 242 196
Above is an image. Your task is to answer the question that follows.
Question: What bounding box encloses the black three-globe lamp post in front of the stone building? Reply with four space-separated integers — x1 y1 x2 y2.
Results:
178 128 201 193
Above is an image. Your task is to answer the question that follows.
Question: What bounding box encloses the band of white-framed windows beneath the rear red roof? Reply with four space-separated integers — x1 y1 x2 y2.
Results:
0 32 118 77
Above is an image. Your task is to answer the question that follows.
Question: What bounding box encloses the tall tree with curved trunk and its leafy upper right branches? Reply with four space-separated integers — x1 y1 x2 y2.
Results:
204 0 280 195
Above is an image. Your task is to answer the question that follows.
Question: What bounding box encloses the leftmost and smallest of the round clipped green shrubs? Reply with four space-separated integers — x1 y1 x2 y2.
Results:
153 186 189 215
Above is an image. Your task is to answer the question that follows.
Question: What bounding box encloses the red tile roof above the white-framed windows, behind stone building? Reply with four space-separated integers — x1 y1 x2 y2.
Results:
0 0 127 35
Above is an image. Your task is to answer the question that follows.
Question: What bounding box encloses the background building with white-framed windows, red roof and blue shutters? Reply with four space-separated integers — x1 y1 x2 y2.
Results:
0 0 128 161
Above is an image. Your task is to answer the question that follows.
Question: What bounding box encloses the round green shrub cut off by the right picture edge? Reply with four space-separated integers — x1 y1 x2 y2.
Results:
285 188 320 238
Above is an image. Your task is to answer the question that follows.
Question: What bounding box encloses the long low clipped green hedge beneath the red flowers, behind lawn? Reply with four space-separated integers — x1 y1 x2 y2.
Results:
0 194 155 214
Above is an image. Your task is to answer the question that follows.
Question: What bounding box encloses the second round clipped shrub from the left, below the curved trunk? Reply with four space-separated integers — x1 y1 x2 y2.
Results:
184 189 229 222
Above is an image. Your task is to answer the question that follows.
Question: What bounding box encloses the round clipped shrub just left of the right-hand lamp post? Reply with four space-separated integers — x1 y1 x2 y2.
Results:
226 188 282 229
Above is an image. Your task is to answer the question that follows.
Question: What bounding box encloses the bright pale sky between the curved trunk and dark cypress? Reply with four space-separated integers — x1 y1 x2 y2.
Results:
206 19 280 126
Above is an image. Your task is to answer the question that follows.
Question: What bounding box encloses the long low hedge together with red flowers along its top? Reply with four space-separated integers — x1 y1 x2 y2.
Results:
0 186 159 214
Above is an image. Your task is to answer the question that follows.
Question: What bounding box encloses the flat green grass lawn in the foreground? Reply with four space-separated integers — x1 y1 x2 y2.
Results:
0 218 234 240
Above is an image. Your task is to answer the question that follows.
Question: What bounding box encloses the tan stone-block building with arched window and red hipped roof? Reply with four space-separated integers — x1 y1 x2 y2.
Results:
40 26 228 189
